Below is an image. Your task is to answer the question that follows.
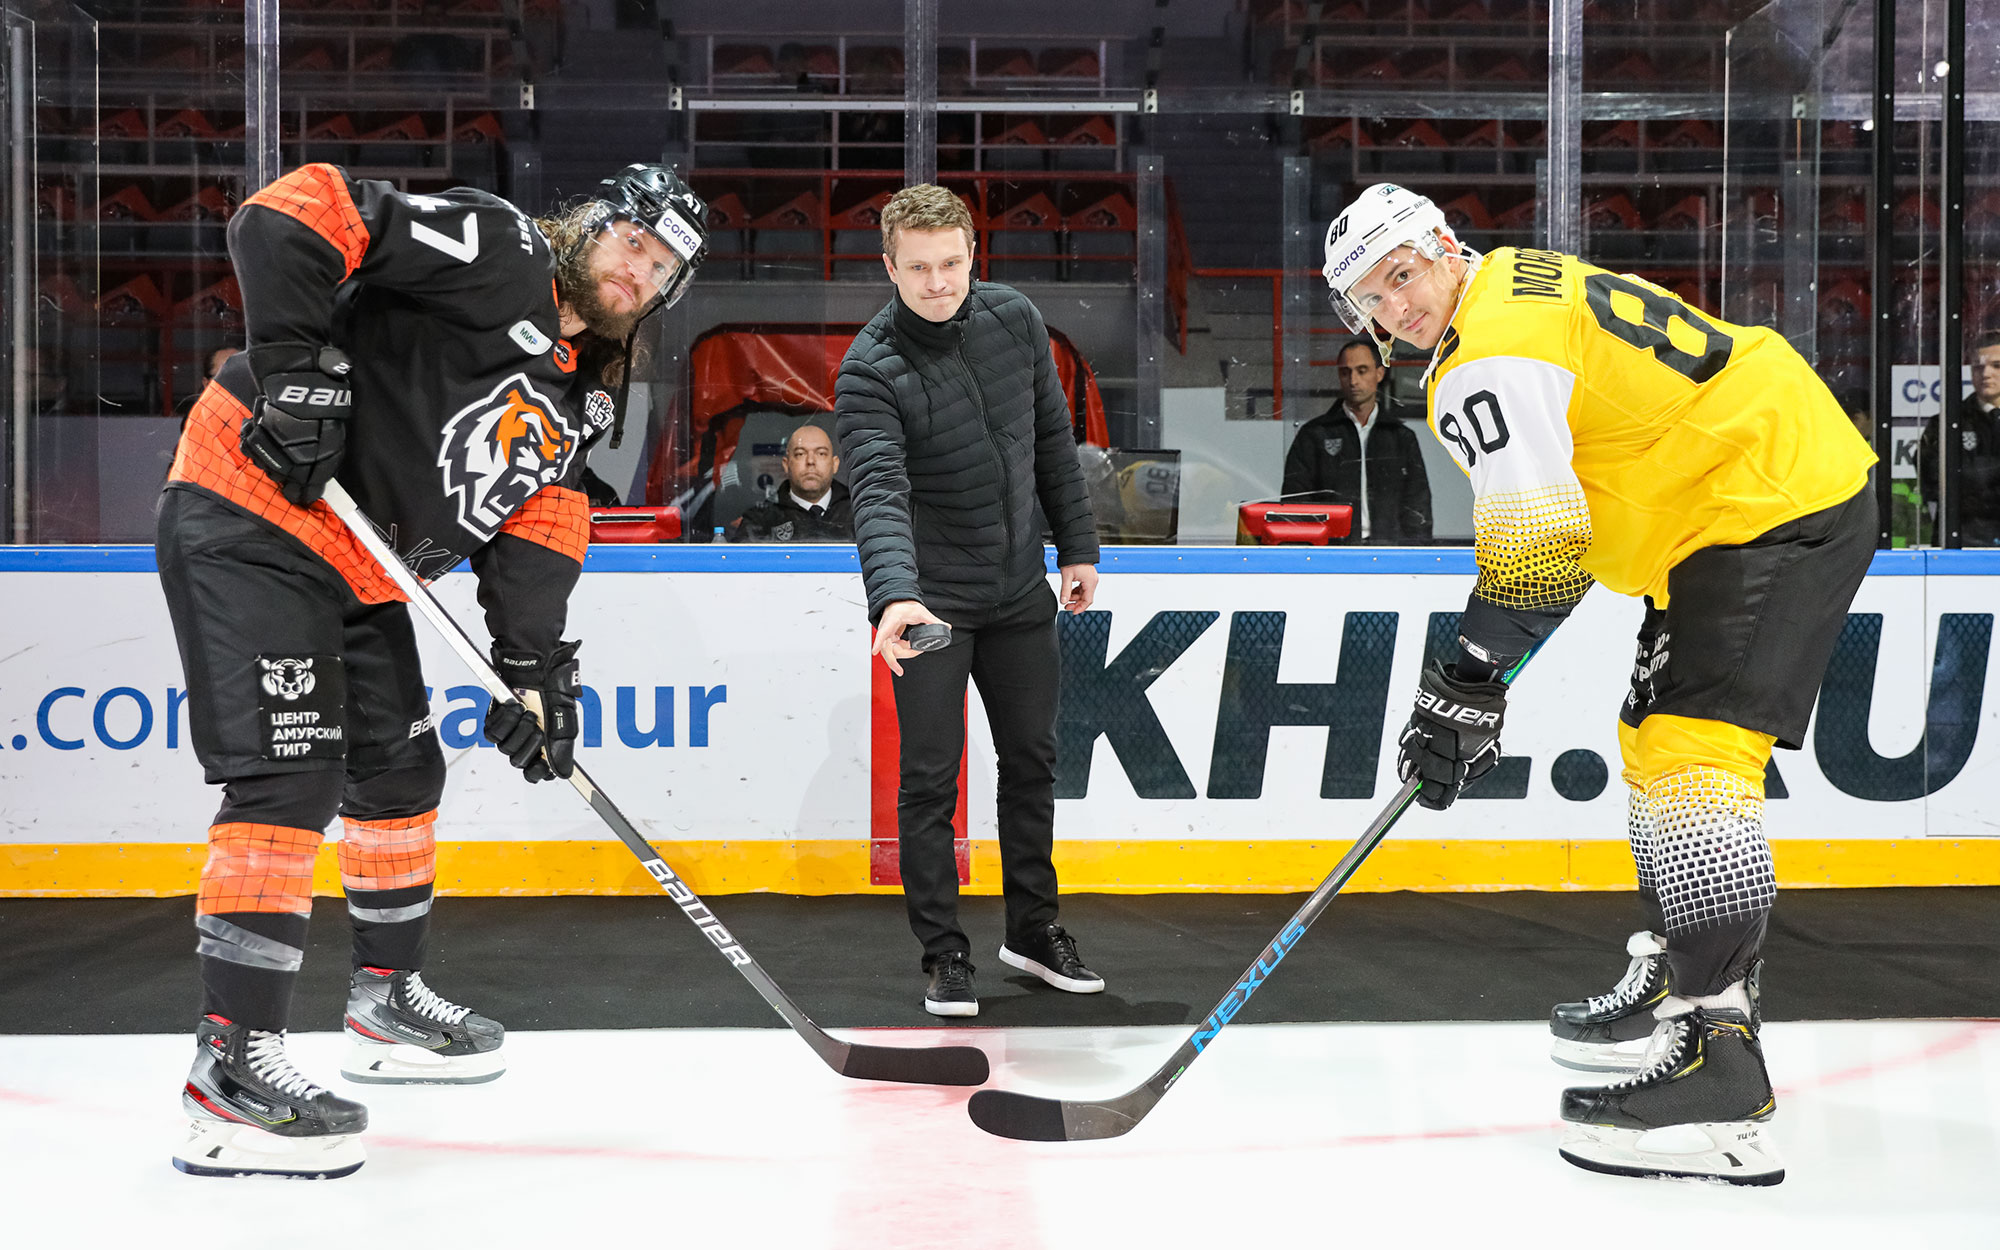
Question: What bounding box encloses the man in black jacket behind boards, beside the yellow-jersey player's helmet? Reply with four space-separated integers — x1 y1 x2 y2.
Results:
1282 338 1430 546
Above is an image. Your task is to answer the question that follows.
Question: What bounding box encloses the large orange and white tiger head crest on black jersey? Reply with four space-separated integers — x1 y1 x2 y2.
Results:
438 374 580 540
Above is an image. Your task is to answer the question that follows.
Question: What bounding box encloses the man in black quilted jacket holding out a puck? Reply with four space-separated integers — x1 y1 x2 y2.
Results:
834 184 1104 1016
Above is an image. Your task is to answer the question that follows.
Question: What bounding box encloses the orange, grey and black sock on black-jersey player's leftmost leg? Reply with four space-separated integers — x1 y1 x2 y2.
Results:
194 822 320 1032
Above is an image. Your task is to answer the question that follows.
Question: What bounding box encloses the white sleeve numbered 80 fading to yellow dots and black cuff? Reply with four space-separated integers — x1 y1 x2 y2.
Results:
1432 356 1590 662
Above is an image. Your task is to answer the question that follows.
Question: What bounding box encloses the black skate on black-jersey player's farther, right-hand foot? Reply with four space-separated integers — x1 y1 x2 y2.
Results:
340 968 506 1086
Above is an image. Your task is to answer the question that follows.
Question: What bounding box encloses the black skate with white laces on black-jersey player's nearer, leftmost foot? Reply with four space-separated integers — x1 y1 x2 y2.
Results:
174 1016 368 1180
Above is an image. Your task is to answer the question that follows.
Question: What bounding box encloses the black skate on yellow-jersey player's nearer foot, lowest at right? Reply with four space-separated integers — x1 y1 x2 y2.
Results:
1562 1008 1784 1184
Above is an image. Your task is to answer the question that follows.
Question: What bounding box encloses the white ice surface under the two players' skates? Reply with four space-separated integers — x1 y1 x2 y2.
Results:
0 1020 2000 1250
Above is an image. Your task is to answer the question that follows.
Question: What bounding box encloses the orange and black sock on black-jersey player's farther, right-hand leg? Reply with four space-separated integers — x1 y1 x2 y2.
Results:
340 808 438 968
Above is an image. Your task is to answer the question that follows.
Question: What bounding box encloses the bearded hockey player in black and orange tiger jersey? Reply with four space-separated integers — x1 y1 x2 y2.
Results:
158 164 706 1176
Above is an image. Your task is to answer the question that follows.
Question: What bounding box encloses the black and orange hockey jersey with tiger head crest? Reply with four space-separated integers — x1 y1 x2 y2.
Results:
168 164 614 652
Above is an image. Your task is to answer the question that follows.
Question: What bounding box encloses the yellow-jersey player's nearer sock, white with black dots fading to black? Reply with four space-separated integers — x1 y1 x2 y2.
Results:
1646 766 1778 998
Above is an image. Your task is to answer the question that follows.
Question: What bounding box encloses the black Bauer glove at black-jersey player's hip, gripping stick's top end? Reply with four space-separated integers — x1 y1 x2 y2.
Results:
242 344 354 508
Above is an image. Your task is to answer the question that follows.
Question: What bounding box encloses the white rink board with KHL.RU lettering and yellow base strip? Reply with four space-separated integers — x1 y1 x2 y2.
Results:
0 546 2000 896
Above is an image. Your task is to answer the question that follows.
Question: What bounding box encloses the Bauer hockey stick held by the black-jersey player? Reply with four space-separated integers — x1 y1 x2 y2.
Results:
326 482 988 1086
